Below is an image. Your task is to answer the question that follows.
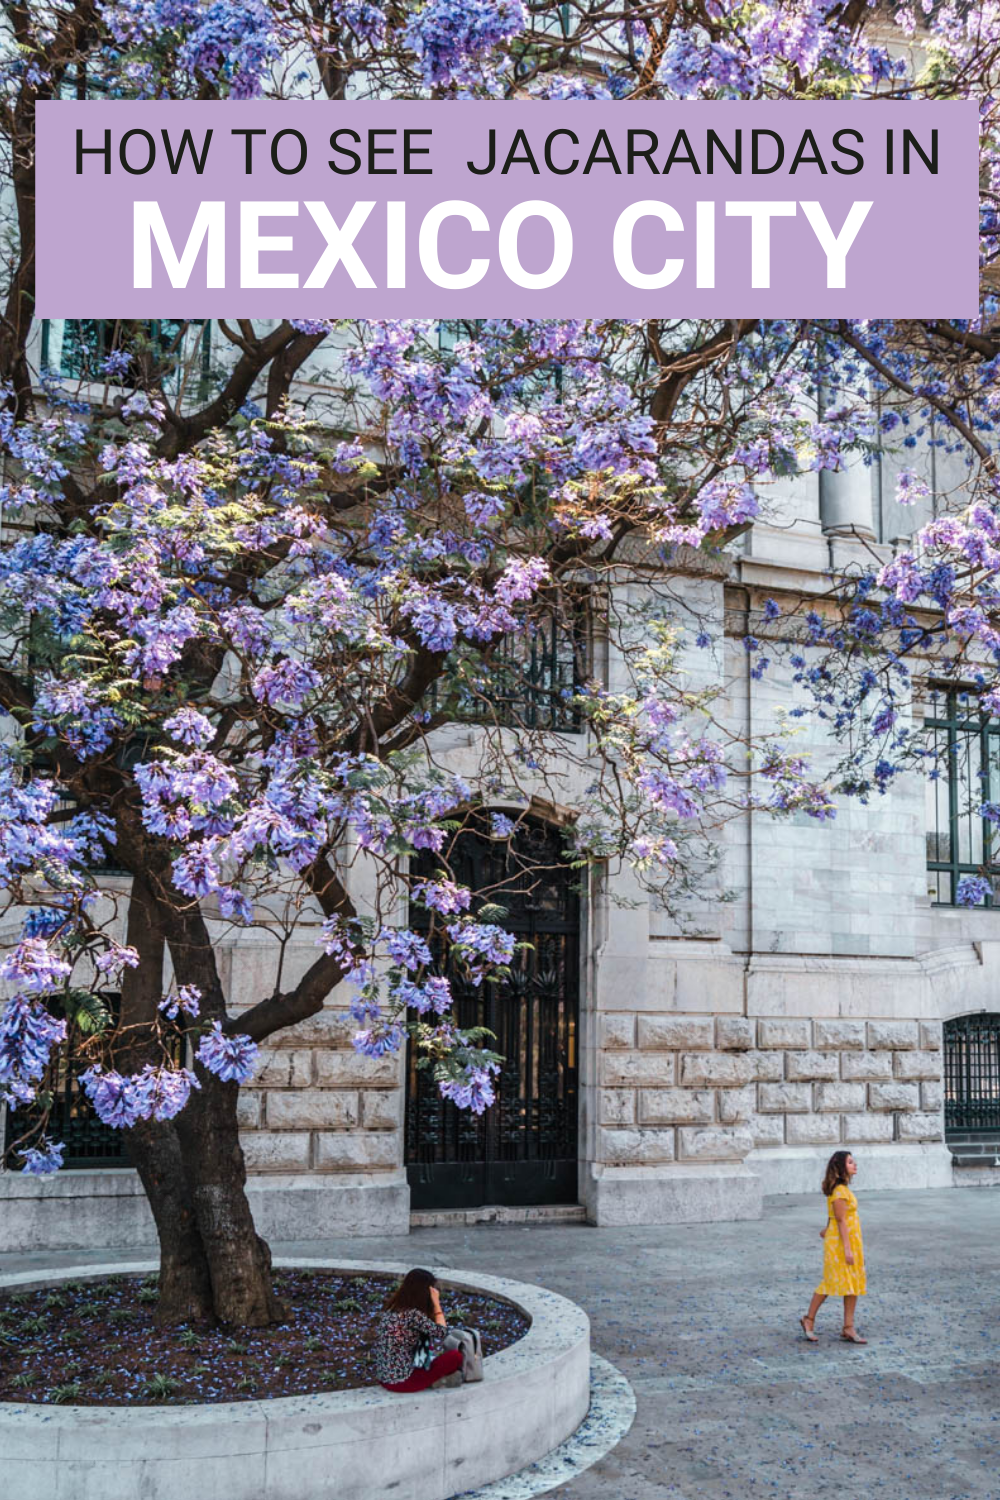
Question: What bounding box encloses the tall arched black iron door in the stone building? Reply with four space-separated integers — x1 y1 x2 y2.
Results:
406 822 580 1209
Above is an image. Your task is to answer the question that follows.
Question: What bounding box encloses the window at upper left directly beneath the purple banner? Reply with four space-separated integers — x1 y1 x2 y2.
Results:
42 318 211 401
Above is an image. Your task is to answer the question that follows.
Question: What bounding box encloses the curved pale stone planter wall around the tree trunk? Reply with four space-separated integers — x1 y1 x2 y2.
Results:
0 1259 591 1500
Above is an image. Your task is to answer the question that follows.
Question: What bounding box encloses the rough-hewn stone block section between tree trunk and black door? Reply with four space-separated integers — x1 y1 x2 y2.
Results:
232 1008 403 1173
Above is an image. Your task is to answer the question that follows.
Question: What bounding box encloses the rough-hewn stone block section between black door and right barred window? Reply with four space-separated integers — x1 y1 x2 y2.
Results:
597 1011 943 1167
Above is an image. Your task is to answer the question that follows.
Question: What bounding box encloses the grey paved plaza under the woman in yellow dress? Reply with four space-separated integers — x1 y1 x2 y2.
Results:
0 1182 1000 1500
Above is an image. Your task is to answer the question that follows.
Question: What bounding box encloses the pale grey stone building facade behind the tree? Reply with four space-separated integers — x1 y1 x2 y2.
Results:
0 331 1000 1248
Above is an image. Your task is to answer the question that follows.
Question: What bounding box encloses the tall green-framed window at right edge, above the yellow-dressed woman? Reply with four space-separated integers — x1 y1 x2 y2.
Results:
924 689 1000 906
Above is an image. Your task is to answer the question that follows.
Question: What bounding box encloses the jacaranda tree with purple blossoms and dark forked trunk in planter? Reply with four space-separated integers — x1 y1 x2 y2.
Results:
0 0 1000 1325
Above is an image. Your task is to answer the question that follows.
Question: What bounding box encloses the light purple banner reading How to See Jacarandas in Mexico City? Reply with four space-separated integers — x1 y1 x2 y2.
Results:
37 101 979 318
